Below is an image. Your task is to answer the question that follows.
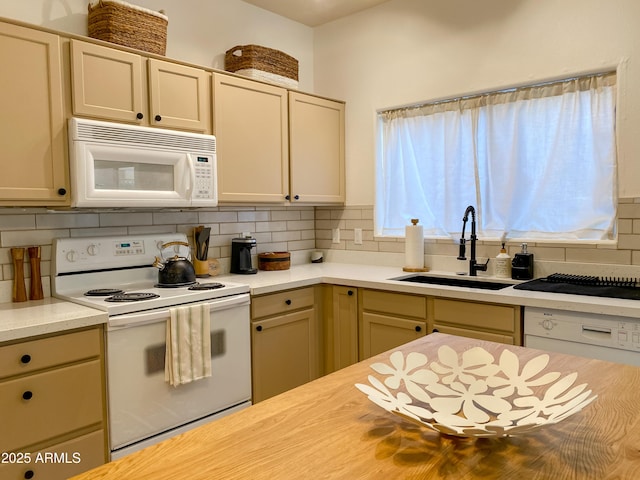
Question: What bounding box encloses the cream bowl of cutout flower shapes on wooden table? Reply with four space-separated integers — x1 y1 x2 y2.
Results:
356 346 597 437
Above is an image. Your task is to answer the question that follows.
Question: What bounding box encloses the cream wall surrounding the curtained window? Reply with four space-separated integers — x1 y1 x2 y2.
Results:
315 0 640 204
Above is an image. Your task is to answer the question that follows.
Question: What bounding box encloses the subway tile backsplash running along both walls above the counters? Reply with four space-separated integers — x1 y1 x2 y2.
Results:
0 199 640 301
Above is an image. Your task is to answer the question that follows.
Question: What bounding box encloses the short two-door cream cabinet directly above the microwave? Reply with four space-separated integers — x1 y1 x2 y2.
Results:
71 40 211 133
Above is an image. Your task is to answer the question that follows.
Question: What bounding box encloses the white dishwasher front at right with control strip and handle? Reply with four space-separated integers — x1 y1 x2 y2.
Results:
524 307 640 352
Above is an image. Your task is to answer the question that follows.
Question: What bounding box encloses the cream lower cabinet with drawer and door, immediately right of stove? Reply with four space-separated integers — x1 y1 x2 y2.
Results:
251 287 321 403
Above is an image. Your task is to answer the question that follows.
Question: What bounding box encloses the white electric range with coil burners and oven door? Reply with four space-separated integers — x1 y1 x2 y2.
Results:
52 233 251 459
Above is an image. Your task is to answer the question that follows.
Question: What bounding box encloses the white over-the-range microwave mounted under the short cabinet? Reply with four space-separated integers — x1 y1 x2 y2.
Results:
69 118 218 208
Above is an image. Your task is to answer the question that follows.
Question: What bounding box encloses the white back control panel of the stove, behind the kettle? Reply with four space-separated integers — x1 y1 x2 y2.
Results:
51 233 189 275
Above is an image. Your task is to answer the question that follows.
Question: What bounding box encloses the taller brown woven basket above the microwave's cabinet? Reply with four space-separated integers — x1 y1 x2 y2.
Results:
87 0 169 55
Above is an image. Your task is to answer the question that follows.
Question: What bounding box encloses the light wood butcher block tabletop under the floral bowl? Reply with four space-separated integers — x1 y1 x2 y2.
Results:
74 333 640 480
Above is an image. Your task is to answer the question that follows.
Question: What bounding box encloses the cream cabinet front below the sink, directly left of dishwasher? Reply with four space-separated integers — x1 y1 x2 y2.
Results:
428 298 522 345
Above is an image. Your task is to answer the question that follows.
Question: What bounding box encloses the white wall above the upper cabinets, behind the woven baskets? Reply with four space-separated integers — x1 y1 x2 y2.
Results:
0 0 314 92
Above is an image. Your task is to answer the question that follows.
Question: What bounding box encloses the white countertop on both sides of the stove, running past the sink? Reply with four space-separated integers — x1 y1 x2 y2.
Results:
0 262 640 343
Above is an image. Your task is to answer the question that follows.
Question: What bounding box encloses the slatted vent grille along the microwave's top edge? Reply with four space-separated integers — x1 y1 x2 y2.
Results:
76 121 216 153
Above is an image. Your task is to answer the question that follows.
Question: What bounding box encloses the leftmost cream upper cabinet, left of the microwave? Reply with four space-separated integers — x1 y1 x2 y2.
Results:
0 23 70 206
